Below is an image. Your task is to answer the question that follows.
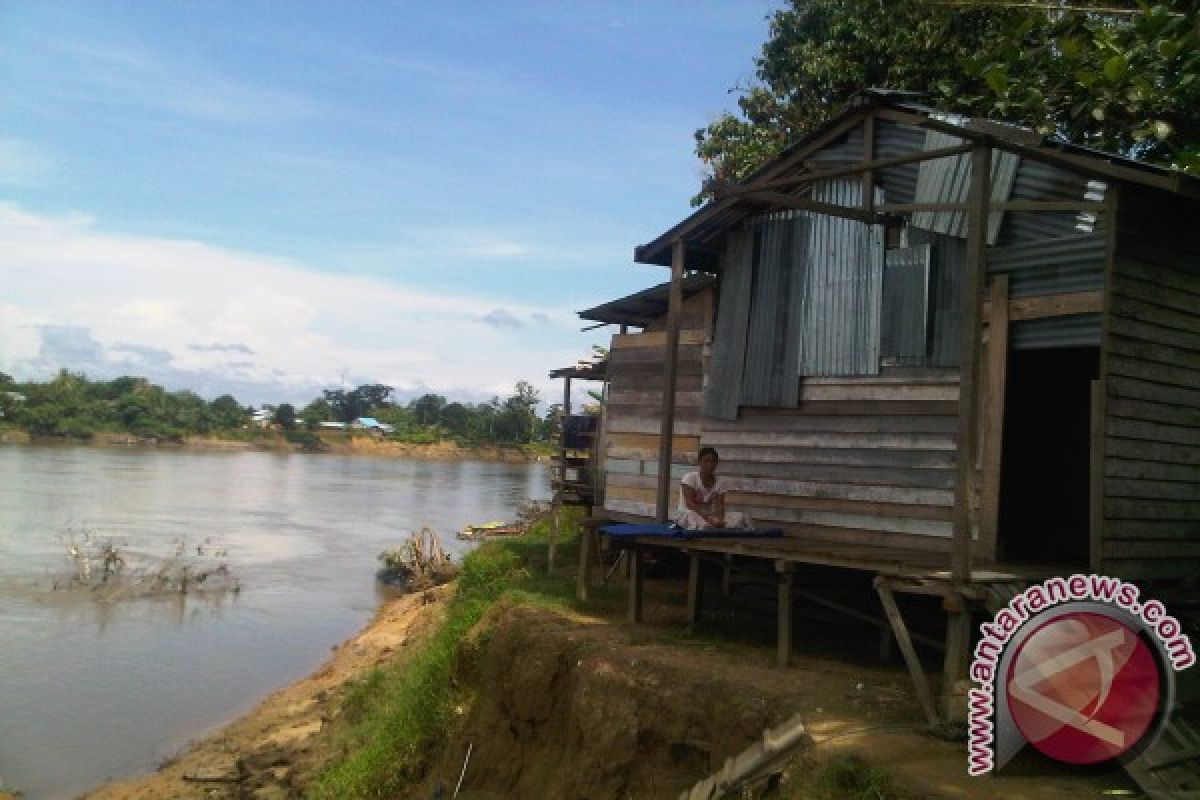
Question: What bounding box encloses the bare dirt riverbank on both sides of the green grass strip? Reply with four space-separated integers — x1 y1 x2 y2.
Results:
79 589 1124 800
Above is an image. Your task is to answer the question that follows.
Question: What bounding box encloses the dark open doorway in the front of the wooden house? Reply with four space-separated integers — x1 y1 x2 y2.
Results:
998 348 1099 566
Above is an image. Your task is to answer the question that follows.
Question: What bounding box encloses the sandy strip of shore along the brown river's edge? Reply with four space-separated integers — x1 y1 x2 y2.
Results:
83 585 454 800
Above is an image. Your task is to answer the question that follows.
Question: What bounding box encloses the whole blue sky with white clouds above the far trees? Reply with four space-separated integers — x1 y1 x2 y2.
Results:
0 0 776 405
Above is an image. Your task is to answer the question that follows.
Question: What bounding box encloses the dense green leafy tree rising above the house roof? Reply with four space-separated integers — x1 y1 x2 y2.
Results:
695 0 1200 203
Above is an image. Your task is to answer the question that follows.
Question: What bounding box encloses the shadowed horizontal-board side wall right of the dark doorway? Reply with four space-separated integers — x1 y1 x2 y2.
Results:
1100 193 1200 581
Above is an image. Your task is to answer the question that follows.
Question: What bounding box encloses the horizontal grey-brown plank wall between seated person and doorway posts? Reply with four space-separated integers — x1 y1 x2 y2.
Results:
701 368 959 551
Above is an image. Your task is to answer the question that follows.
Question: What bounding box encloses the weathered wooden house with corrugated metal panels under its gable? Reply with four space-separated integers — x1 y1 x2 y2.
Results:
597 91 1200 595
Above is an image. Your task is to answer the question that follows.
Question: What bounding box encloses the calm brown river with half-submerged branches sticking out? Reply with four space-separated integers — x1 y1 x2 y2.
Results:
0 445 550 800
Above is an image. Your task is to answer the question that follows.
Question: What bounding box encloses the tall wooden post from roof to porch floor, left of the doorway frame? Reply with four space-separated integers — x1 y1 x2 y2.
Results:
950 144 991 587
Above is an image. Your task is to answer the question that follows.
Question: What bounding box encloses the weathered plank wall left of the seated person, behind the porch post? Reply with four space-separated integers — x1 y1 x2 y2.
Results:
604 331 707 518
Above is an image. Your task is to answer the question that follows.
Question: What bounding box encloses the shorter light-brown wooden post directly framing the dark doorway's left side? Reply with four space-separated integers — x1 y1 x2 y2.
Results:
979 275 1008 561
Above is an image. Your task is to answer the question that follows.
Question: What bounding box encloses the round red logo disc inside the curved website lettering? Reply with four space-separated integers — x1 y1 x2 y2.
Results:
1006 612 1162 764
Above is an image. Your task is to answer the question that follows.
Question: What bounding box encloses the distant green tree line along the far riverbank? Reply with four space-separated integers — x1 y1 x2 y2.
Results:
0 369 560 444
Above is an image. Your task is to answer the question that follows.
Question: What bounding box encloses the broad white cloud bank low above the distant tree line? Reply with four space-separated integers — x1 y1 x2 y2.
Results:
0 205 587 403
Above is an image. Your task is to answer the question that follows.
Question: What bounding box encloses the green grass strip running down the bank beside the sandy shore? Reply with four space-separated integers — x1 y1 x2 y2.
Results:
308 510 578 800
